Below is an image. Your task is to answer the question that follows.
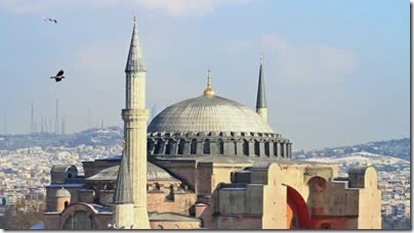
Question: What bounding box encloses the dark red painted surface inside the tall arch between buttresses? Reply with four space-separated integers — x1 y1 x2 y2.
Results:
287 186 311 229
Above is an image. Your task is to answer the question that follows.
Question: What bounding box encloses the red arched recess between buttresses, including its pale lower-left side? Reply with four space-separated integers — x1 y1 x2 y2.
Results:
286 186 311 229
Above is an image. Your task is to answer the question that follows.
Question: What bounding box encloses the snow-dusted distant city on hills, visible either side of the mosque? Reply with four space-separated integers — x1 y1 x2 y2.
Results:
0 127 411 229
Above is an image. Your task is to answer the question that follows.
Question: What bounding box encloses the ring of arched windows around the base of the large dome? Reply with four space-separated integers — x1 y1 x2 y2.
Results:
147 139 291 158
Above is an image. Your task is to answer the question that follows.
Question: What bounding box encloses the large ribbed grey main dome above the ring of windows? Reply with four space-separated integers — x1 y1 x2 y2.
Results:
148 95 273 133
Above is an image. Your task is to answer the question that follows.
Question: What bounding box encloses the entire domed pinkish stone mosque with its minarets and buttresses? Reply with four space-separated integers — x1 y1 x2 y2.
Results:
45 17 381 229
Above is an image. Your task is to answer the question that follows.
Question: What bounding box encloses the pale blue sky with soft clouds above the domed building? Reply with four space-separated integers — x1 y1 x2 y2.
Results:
0 0 410 150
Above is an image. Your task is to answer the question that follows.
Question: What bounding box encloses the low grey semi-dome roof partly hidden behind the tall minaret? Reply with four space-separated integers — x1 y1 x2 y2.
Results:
86 162 178 181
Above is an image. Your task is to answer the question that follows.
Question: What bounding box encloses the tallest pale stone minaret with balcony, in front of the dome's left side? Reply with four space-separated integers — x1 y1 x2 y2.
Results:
122 17 150 229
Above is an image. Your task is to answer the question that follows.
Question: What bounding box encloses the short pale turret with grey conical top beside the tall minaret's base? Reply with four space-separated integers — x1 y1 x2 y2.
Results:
112 149 135 229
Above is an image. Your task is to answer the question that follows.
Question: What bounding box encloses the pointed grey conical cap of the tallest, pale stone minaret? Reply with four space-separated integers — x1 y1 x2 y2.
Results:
125 17 146 72
